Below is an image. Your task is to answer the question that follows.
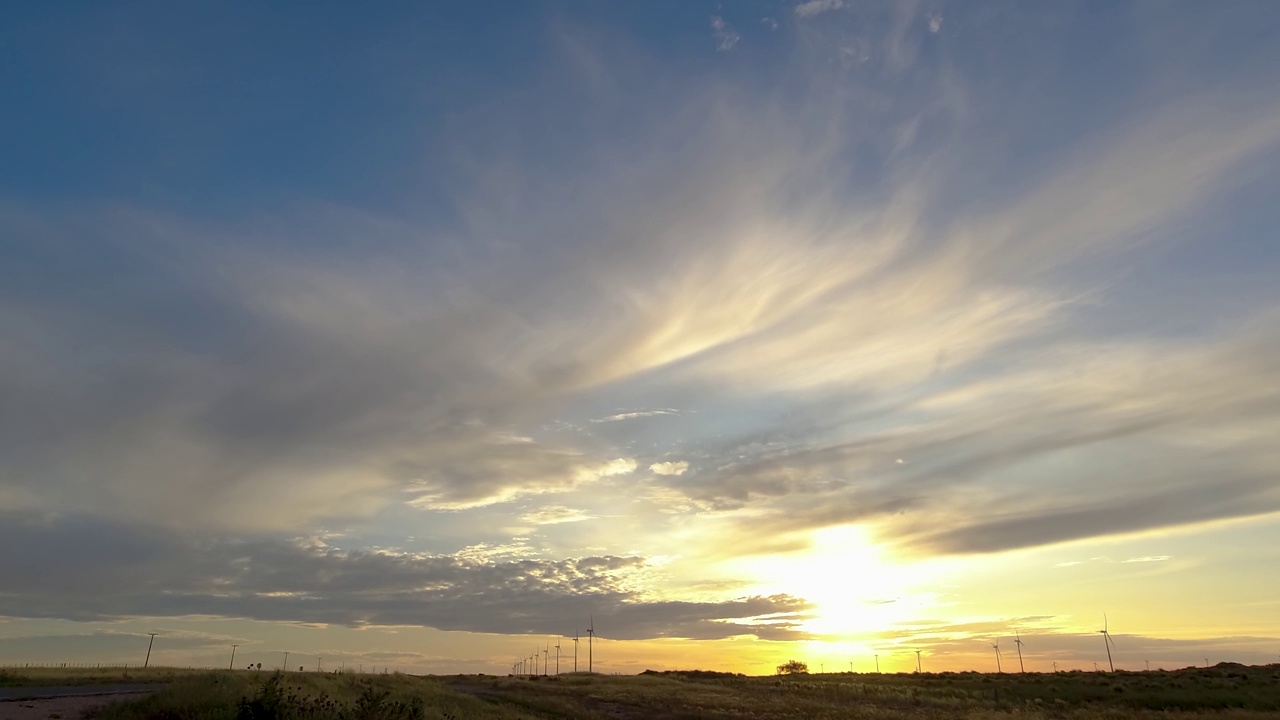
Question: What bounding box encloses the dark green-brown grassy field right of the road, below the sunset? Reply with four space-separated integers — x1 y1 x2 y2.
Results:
5 665 1280 720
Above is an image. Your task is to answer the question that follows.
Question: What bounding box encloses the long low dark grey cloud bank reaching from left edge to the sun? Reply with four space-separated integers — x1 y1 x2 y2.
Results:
0 512 808 639
